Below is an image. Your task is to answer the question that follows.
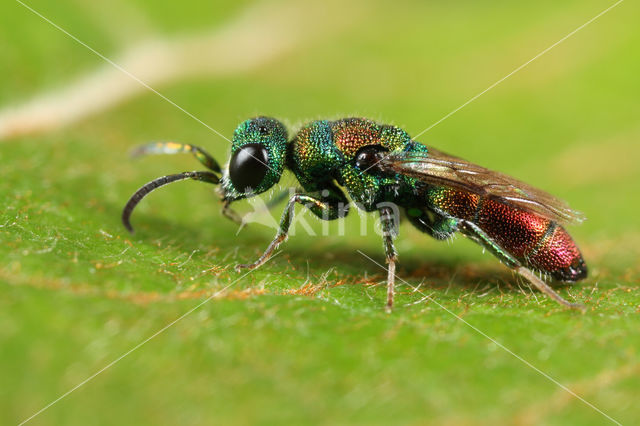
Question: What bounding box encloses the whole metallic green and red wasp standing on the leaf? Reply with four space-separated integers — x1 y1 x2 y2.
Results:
122 117 587 310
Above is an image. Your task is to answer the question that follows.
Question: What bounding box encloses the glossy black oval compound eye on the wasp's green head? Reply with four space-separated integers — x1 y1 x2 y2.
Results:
229 143 269 192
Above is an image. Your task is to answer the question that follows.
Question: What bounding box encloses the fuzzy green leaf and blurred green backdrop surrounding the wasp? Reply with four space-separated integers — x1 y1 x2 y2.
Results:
0 0 640 425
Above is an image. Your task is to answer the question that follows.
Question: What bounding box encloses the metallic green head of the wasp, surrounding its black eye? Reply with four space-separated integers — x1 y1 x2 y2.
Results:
222 117 287 200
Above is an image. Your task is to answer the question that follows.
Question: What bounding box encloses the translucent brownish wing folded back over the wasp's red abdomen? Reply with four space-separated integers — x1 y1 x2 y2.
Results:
380 148 584 223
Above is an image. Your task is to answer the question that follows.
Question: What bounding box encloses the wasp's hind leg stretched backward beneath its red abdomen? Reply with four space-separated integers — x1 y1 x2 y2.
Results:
460 222 586 311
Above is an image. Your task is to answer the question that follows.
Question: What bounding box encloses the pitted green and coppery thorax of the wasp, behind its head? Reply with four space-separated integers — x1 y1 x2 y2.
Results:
289 118 427 210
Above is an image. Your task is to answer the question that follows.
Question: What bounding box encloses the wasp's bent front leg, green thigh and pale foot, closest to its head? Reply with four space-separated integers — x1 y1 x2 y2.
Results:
236 187 349 271
